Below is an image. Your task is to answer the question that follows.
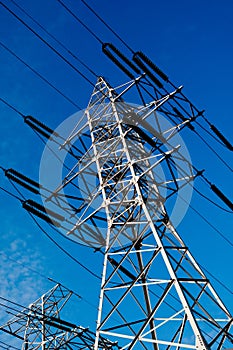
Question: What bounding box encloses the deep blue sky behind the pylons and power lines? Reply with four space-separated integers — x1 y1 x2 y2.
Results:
0 0 233 344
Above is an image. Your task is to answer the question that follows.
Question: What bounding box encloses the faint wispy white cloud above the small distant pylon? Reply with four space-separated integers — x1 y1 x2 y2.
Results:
0 228 47 345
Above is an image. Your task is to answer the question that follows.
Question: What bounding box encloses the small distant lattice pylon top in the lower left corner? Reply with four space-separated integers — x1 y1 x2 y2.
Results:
0 284 118 350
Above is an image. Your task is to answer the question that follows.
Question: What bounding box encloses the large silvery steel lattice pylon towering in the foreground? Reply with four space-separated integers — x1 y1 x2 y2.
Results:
49 78 232 350
